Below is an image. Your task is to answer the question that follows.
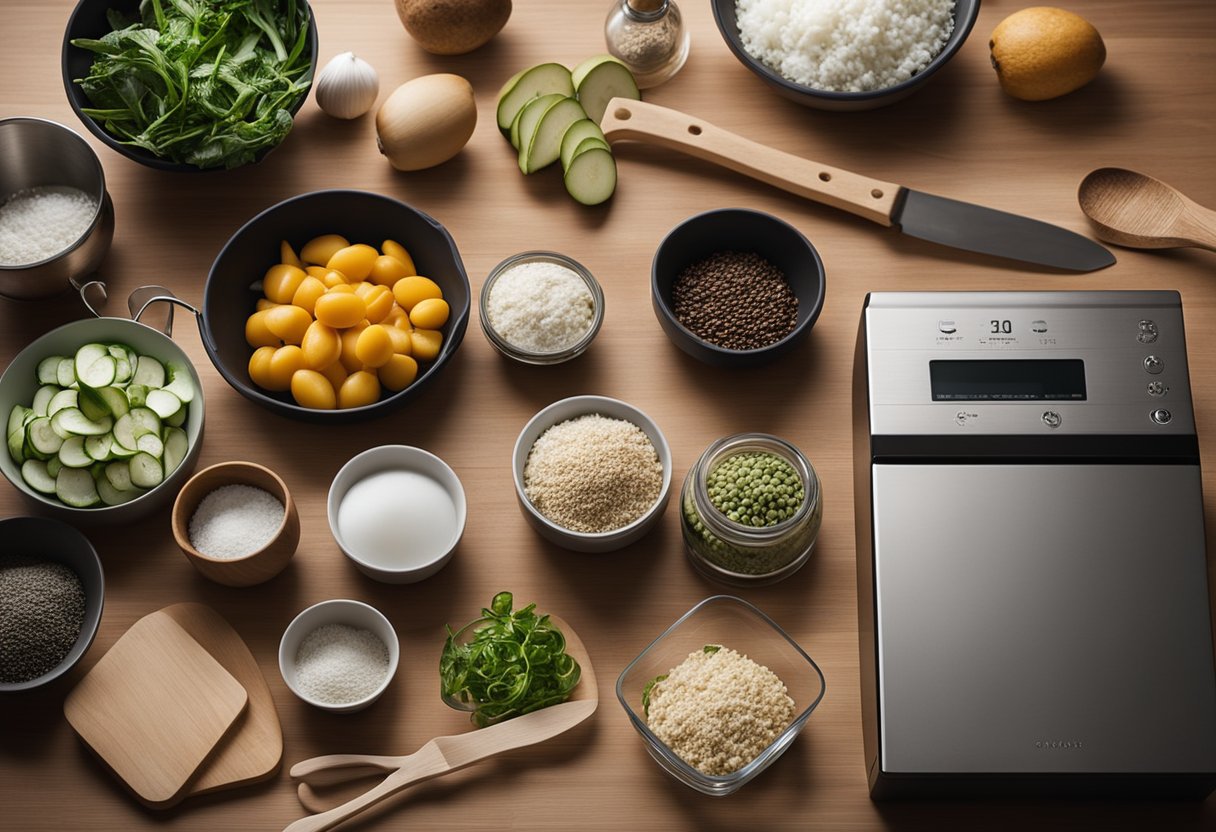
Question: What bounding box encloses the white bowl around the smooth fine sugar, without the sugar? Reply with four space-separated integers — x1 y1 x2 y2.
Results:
328 445 467 584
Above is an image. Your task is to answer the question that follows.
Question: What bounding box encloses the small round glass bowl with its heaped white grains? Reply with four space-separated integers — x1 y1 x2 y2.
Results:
478 252 604 365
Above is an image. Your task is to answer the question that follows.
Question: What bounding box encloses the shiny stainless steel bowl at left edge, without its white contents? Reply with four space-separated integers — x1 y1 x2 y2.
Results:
0 116 114 300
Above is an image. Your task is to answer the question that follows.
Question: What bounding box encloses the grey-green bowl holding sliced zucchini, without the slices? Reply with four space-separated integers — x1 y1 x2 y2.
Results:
0 317 204 525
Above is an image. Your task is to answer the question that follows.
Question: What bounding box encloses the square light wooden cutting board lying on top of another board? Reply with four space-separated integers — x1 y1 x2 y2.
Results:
63 612 248 808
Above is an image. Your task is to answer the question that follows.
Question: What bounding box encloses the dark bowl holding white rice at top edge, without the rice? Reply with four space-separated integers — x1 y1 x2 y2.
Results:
713 0 980 109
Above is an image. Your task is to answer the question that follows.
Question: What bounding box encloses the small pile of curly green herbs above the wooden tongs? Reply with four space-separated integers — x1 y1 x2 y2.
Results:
439 592 581 727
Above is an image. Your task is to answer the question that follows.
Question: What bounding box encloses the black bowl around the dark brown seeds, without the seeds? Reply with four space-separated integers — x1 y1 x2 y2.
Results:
651 208 826 367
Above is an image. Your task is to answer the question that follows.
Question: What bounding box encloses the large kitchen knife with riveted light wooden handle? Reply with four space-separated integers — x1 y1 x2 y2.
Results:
599 99 1115 271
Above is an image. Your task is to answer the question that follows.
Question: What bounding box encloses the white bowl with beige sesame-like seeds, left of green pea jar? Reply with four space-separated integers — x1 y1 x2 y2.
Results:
512 395 671 552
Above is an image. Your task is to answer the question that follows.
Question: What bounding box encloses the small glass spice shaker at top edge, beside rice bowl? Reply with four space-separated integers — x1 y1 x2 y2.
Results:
604 0 689 90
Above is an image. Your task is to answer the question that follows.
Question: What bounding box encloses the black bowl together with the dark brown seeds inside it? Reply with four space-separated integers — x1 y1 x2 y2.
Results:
651 208 826 367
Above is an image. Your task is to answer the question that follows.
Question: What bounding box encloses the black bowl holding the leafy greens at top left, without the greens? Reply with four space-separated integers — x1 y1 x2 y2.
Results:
60 0 317 173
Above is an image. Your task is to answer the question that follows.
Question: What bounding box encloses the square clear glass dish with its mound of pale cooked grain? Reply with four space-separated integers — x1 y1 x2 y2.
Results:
617 595 824 797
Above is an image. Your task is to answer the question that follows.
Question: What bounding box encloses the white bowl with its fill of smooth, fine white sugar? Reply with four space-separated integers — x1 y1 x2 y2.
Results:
328 445 467 584
